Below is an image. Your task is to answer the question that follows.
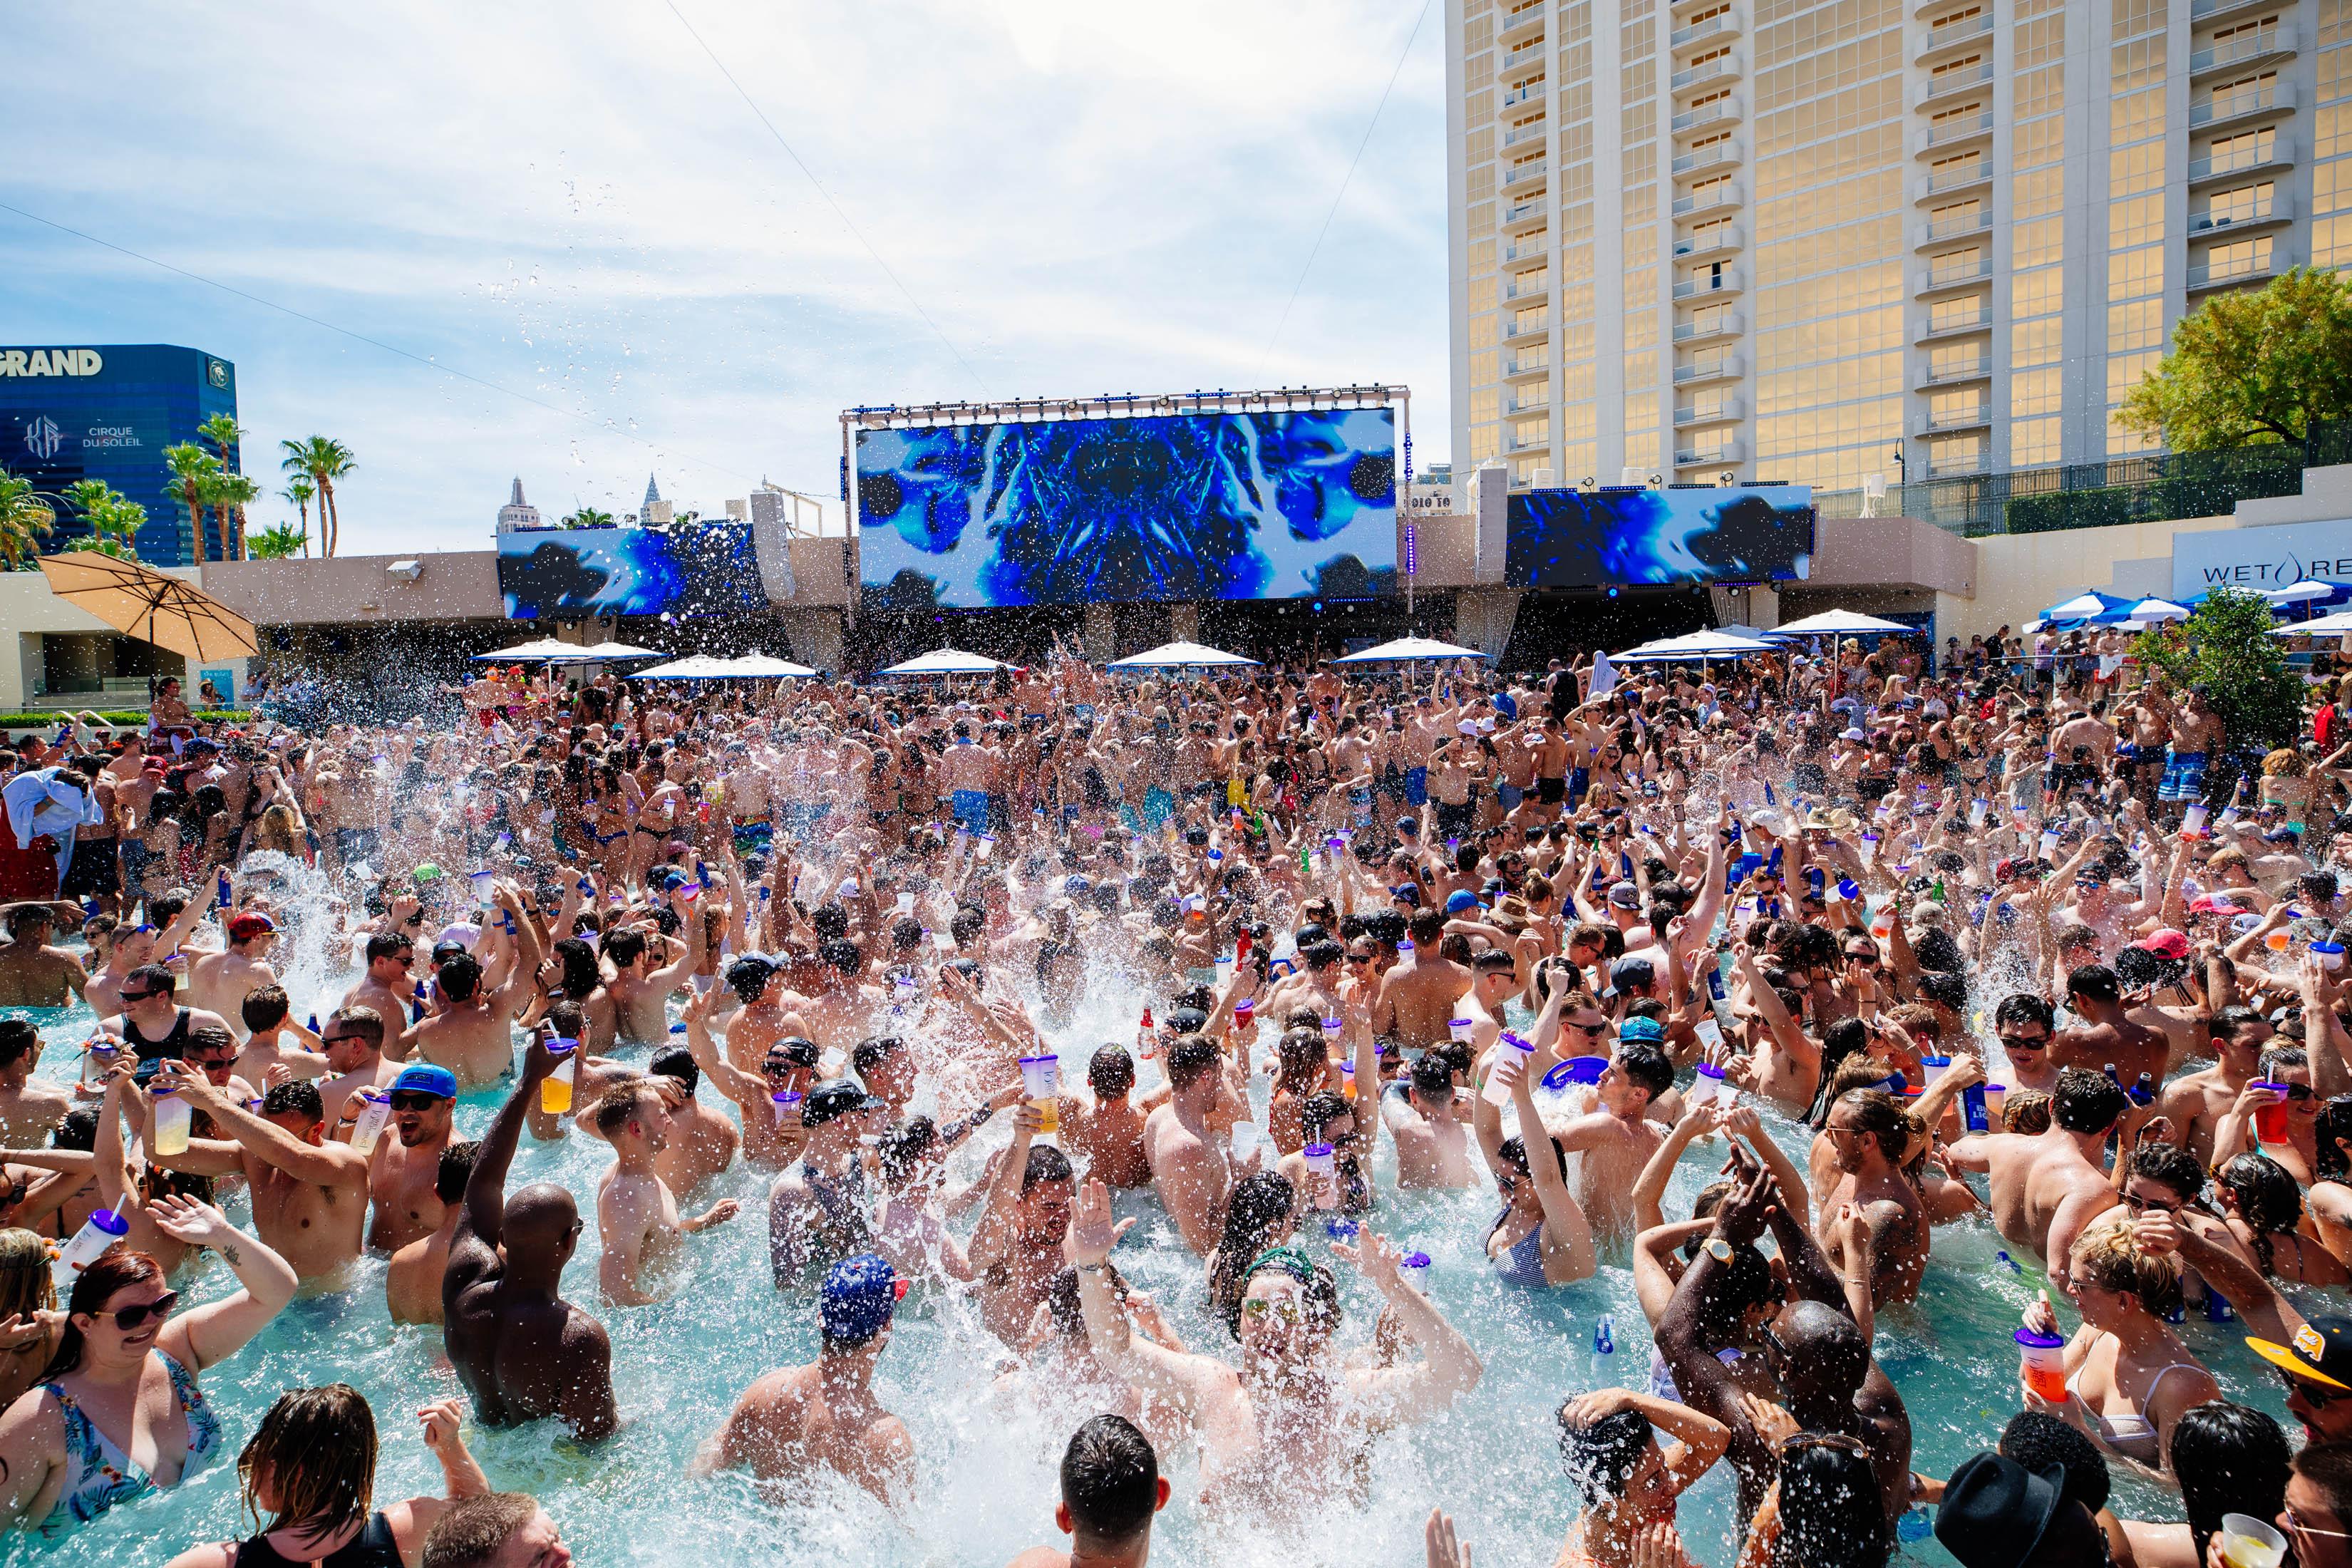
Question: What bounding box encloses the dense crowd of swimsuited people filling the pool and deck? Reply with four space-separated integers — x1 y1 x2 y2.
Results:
0 639 2352 1568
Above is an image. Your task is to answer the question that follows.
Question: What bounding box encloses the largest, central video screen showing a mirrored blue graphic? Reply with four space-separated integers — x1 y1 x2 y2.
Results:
859 409 1397 609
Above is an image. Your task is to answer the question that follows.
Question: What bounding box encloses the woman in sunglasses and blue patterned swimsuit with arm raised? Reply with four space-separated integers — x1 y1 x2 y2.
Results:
0 1197 296 1537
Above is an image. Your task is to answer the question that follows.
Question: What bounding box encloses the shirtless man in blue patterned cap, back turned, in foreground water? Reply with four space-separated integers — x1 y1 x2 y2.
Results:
691 1253 915 1507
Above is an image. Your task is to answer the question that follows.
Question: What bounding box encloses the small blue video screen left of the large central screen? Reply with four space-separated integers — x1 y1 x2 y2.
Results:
499 522 767 621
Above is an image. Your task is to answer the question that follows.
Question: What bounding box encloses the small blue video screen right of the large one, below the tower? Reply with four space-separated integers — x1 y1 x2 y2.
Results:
1503 484 1813 588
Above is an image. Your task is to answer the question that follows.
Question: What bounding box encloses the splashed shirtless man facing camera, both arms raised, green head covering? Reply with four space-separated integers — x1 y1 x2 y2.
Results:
1068 1182 1484 1519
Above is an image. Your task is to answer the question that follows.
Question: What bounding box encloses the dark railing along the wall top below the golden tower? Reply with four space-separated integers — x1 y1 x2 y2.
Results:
1813 421 2352 538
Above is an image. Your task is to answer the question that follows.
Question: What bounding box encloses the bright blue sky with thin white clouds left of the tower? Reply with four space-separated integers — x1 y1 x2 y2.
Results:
0 0 1449 555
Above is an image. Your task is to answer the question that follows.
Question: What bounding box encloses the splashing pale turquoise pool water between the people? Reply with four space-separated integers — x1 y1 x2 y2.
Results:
0 931 2294 1568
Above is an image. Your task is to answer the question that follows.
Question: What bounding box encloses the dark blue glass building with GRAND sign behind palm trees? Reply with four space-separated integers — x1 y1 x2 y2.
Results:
0 344 242 567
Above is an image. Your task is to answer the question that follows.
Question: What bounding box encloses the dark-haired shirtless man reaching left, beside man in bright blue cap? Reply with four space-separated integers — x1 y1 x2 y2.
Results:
146 1063 367 1293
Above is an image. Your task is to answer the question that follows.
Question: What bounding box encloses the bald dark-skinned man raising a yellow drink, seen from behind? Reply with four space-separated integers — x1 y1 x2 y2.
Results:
442 1041 621 1443
